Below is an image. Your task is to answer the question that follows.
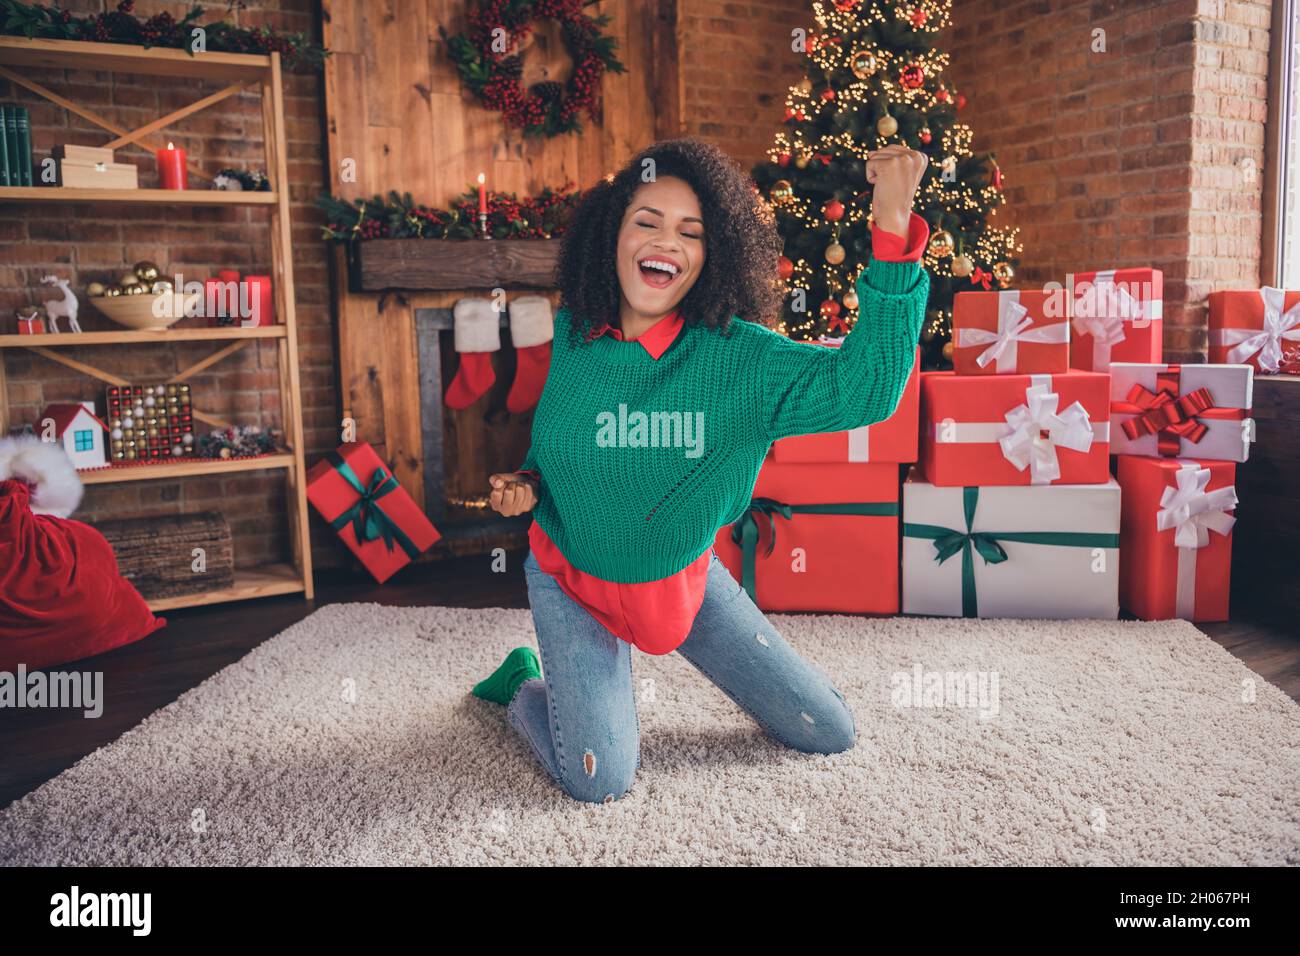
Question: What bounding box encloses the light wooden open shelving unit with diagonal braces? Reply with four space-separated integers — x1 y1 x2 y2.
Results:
0 36 313 611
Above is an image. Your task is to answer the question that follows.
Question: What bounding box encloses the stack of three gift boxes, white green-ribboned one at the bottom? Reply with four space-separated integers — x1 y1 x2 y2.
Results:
902 280 1121 618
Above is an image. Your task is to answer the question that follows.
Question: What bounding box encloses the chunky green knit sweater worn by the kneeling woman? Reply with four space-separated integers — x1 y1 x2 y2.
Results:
520 259 930 583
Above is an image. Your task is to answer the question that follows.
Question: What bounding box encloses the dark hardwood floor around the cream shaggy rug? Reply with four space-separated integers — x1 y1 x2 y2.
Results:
0 551 1300 806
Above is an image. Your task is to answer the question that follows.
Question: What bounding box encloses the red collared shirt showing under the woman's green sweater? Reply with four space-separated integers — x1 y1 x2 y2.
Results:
514 212 930 654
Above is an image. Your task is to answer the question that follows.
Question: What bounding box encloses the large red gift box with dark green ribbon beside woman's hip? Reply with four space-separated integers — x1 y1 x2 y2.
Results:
714 460 900 614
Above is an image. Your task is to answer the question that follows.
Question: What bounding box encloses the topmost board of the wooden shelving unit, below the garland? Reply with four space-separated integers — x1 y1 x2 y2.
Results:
0 36 270 81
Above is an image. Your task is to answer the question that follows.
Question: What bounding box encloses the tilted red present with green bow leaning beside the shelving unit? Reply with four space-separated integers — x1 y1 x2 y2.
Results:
307 442 442 584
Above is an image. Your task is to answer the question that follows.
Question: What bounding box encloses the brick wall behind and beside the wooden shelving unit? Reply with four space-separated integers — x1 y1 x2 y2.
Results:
0 0 339 566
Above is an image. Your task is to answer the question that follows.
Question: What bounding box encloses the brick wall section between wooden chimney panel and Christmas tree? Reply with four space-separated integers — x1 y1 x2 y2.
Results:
677 0 815 169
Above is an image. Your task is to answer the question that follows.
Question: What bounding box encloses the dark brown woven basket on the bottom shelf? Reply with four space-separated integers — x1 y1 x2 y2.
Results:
95 511 234 600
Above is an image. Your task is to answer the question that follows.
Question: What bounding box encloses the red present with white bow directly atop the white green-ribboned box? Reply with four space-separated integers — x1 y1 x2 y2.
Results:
920 372 1110 488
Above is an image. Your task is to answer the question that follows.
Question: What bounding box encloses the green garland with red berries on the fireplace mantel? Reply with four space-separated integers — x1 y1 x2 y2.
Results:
316 182 581 242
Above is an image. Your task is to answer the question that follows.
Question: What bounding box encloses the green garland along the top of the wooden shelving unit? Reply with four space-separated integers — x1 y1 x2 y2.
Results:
0 0 330 69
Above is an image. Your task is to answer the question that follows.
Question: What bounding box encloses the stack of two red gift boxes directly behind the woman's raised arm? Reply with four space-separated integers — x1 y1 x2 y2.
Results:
714 339 920 614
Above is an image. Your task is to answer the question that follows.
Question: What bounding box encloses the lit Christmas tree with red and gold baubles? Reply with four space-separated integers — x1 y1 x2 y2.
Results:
753 0 1021 368
